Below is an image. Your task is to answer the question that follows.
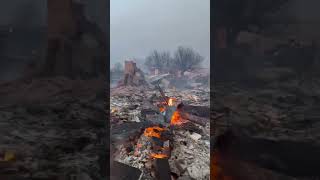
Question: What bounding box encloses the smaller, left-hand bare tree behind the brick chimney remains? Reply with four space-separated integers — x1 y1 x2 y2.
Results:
145 50 172 72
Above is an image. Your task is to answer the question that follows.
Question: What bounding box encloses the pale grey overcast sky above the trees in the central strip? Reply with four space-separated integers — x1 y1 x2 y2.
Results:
110 0 210 64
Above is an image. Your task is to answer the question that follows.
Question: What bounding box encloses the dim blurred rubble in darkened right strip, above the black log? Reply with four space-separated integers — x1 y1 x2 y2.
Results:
212 79 320 179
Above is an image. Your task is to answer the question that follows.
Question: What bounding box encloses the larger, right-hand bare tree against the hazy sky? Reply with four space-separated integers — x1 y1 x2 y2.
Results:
173 46 204 74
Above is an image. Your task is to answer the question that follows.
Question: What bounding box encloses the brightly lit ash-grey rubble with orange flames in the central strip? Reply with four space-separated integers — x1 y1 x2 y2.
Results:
110 62 210 179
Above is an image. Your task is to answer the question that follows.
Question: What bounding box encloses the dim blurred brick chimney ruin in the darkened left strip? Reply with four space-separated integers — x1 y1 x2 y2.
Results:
43 0 107 78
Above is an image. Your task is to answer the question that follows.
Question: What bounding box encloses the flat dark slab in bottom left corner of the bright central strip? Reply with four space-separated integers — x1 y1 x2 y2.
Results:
110 161 142 180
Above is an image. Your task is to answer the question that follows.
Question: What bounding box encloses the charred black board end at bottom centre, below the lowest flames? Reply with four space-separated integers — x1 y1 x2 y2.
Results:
153 159 171 180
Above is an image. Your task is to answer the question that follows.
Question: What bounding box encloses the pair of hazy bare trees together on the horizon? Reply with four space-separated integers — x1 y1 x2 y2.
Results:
145 46 204 74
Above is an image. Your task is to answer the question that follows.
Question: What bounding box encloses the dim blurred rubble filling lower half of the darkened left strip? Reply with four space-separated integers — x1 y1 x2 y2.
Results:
0 77 106 179
